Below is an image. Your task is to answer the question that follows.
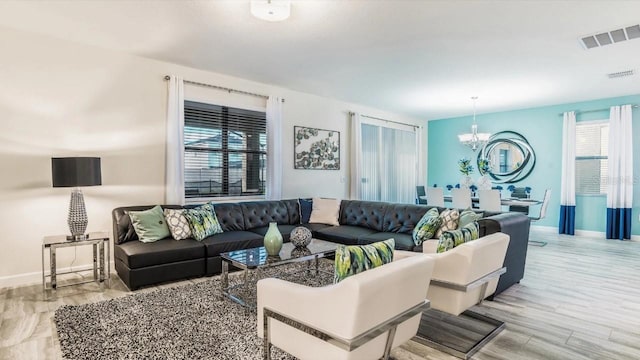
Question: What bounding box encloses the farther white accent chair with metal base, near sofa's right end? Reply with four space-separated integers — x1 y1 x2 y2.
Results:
414 232 509 359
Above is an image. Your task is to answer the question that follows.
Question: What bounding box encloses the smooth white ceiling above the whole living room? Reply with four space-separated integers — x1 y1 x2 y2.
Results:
0 0 640 119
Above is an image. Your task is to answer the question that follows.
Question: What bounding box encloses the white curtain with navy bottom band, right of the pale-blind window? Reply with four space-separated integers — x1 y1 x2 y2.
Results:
606 105 633 240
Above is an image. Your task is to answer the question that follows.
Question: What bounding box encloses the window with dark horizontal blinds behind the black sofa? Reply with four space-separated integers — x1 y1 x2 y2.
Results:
184 101 267 200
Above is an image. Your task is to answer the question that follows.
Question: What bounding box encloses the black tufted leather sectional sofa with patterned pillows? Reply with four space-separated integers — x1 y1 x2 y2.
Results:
112 199 529 294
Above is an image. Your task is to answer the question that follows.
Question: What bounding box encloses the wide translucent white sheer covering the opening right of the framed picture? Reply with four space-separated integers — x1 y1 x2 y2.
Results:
360 119 419 203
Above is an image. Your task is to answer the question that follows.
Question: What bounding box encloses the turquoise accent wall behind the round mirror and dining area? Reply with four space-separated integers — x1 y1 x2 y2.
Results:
427 95 640 235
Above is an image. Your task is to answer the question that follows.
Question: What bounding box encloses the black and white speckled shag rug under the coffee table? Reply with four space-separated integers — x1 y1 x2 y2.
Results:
54 261 333 360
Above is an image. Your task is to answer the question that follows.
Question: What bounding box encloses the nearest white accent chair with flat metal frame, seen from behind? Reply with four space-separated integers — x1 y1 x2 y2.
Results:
258 251 435 360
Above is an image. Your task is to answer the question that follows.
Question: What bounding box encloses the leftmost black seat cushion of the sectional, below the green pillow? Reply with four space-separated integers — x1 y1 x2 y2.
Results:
113 239 205 269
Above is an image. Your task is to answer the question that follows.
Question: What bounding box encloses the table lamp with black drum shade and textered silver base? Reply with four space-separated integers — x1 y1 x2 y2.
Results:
51 157 102 241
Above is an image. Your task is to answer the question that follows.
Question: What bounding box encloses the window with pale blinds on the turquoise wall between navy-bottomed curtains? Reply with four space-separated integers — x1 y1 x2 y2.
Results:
576 121 609 195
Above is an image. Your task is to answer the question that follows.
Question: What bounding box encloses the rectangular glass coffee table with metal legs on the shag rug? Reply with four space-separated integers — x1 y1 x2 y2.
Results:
220 239 338 307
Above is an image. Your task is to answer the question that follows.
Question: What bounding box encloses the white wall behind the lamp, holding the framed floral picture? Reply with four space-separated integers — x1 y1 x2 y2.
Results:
0 28 426 287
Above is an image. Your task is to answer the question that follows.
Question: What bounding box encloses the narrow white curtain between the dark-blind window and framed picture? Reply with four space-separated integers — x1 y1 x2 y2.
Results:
266 96 282 200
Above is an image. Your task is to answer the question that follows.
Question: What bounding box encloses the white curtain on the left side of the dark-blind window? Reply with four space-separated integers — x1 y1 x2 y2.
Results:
165 75 184 205
